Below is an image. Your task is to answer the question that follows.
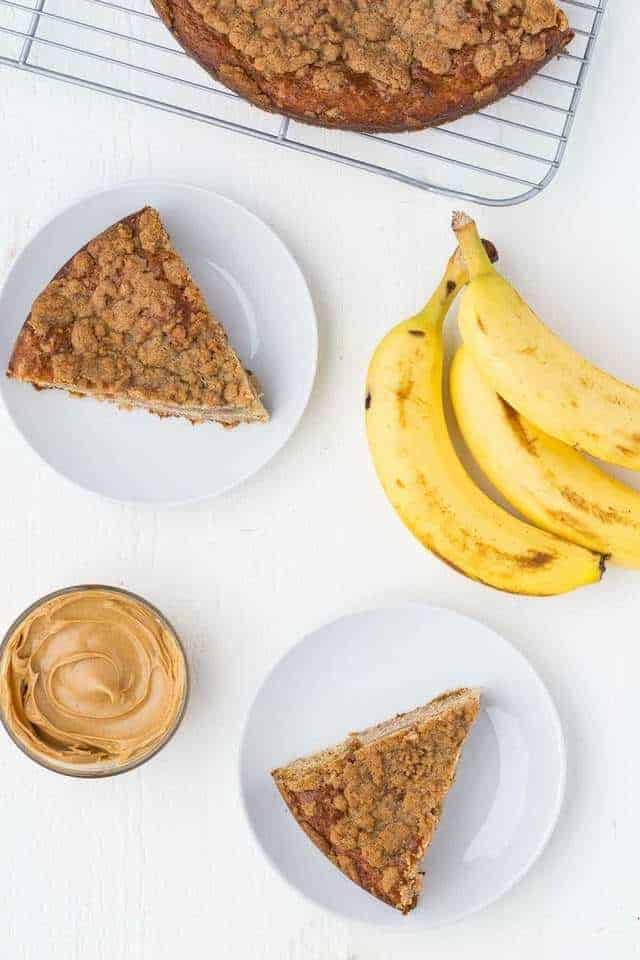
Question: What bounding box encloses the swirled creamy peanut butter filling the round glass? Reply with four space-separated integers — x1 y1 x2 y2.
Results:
0 588 187 771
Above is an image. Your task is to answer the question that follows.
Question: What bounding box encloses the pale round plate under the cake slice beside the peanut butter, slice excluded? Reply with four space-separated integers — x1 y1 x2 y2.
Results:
240 605 565 928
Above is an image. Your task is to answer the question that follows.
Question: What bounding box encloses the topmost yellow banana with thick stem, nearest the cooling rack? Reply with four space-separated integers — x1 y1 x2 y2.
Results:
453 214 640 470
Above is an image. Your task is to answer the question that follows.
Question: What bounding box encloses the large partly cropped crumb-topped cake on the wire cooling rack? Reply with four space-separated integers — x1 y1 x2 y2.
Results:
152 0 573 131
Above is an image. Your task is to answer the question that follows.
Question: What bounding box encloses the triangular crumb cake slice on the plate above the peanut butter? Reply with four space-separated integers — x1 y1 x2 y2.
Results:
7 207 269 426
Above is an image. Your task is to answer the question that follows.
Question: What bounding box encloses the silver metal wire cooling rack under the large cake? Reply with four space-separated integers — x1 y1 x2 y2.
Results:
0 0 607 205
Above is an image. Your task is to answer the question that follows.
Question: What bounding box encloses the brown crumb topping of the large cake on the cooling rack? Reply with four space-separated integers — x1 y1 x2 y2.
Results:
190 0 568 91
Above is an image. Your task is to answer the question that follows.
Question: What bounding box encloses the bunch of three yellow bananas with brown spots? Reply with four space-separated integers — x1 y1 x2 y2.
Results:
365 214 640 596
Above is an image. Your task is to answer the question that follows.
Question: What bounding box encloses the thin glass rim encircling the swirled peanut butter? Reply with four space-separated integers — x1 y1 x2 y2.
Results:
0 583 191 780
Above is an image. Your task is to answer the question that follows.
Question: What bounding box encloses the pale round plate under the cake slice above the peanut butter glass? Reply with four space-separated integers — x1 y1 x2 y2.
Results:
0 181 317 504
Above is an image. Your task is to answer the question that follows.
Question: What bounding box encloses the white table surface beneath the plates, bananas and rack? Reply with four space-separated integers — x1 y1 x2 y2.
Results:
0 7 640 960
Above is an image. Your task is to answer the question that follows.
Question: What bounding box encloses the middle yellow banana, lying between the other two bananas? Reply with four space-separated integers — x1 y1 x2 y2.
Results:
449 347 640 567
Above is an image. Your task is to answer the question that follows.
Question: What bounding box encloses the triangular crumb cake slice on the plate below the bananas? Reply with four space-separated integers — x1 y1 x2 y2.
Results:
272 688 480 913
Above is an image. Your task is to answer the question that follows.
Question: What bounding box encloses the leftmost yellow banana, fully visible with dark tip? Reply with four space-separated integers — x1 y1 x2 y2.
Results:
365 252 603 595
